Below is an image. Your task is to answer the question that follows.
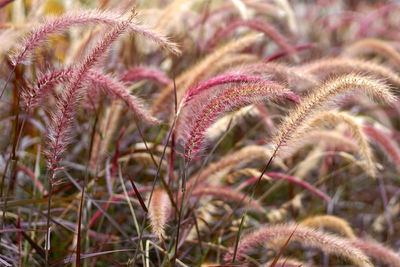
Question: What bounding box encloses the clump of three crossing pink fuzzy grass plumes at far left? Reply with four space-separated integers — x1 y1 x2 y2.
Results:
13 6 180 261
